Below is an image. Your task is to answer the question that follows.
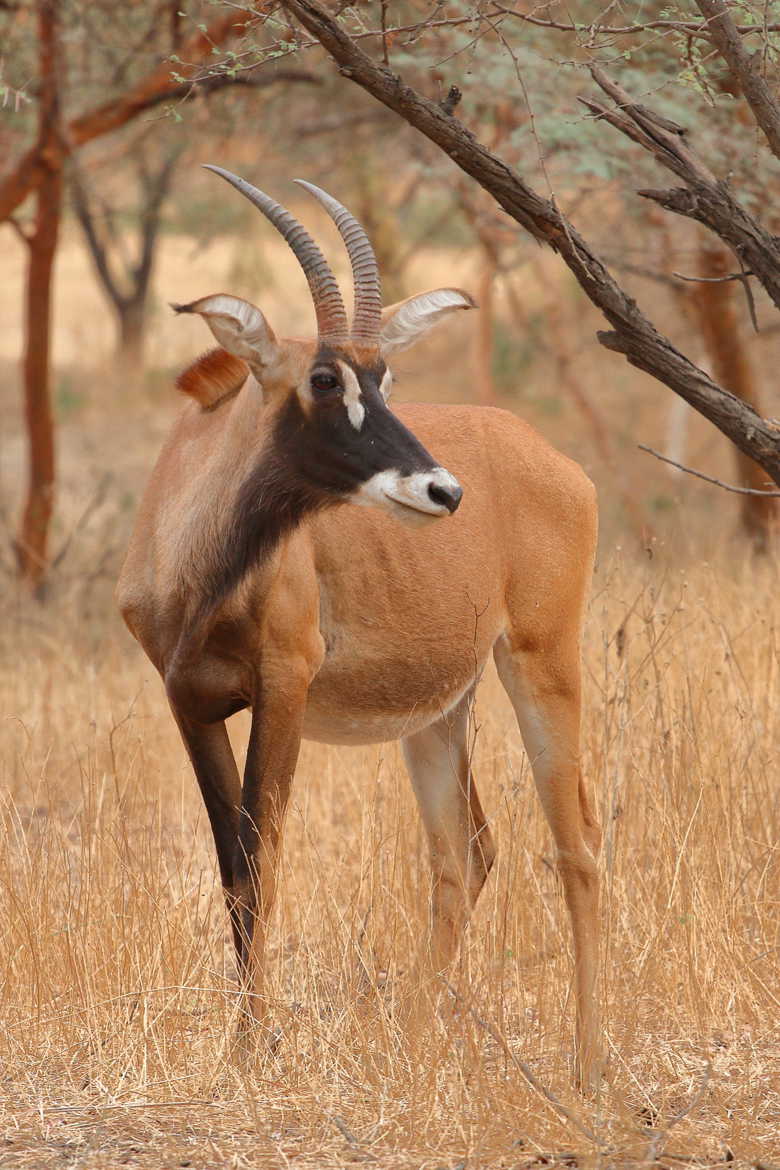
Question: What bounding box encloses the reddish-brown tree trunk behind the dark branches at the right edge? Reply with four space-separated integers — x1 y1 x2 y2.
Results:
689 240 779 552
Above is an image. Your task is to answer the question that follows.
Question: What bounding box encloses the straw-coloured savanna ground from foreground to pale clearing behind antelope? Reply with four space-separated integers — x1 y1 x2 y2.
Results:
0 223 780 1170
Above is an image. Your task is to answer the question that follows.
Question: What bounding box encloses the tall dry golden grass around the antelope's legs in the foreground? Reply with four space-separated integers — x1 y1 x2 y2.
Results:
0 535 780 1168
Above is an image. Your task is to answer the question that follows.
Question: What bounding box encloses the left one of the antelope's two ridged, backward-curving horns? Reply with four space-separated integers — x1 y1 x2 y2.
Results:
205 164 350 342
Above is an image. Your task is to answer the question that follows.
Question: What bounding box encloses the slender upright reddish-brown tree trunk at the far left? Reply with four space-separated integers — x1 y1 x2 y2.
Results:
16 0 62 591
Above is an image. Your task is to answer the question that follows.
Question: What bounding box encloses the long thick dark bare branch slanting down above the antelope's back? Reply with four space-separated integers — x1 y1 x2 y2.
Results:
284 0 780 484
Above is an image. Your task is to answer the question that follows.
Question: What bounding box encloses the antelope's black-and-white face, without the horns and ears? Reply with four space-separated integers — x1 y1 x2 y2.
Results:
288 345 463 519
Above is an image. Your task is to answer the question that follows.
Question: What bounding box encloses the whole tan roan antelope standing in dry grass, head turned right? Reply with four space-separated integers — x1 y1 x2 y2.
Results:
118 167 600 1086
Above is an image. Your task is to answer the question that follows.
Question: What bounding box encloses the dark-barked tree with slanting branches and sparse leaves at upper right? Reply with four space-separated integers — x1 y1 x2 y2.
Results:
251 0 780 540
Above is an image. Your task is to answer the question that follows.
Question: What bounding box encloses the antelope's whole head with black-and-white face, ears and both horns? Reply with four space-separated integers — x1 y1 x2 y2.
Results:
173 166 474 519
